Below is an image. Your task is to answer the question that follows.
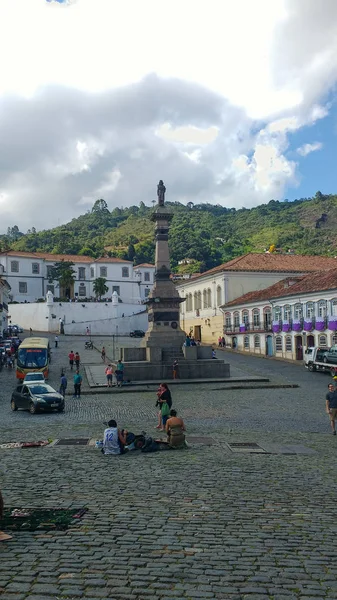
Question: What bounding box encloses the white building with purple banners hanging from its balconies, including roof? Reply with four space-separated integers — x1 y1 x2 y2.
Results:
222 268 337 360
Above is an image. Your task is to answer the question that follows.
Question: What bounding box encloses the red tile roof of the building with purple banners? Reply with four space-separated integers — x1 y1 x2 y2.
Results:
224 268 337 308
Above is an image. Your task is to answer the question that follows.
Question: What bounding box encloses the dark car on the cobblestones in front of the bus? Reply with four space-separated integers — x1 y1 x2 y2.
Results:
11 382 64 415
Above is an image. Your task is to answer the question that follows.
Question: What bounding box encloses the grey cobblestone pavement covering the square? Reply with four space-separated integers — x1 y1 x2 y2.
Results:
0 338 337 600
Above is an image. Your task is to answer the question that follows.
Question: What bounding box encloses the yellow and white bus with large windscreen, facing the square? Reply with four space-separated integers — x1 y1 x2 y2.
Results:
16 337 50 379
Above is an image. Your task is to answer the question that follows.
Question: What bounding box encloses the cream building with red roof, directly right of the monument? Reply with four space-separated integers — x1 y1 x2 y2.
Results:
176 253 337 343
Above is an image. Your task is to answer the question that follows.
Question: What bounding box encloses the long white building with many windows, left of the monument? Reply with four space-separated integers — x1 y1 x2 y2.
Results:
0 250 154 304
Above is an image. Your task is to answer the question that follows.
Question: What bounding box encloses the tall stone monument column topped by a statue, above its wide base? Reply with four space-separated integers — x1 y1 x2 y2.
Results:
142 180 185 350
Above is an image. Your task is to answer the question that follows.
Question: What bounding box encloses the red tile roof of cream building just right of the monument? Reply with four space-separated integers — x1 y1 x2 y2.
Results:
193 252 337 277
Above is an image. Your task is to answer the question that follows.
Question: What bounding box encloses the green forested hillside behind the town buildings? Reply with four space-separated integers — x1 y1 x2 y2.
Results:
0 192 337 272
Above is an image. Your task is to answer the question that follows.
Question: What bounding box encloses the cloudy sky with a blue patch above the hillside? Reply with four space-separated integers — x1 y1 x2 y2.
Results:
0 0 337 233
